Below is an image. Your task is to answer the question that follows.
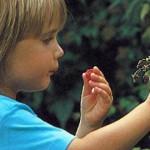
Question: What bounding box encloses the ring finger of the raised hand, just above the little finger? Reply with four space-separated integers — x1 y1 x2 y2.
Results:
89 80 112 95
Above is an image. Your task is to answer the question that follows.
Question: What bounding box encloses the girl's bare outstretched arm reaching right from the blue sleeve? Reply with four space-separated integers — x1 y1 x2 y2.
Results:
68 95 150 150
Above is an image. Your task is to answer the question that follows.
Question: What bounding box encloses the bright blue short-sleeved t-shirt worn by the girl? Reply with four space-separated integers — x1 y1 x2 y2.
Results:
0 95 74 150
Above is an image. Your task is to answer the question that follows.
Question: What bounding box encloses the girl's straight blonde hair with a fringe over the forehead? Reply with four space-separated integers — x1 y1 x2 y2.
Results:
0 0 66 70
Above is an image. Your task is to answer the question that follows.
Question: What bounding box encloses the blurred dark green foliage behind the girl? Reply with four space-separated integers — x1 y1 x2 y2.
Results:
18 0 150 150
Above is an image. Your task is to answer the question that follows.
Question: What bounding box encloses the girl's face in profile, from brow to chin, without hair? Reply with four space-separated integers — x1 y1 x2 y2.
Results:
6 26 64 92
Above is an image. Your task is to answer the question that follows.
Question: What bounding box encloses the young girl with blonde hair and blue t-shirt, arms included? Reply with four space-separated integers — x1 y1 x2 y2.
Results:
0 0 150 150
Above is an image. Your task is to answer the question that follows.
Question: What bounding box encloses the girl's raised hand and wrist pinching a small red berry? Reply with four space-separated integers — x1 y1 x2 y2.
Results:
76 67 112 138
